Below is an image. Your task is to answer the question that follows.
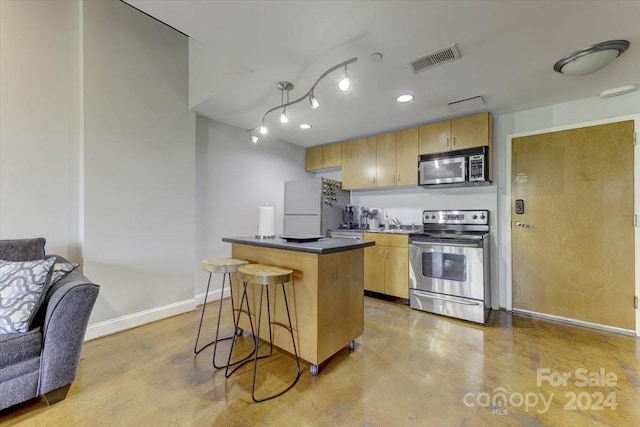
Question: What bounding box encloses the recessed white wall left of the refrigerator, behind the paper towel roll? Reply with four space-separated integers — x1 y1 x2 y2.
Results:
194 116 312 295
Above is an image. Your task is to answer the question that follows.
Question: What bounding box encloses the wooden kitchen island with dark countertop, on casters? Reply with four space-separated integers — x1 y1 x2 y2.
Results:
222 237 374 375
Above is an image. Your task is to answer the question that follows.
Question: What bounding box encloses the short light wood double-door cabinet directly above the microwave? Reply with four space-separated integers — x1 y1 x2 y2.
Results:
418 113 491 154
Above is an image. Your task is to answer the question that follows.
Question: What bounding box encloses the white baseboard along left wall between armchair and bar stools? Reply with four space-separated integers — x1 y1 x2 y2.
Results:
84 287 230 341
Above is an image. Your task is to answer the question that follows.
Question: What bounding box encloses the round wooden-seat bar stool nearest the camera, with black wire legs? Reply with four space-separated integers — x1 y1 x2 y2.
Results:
227 264 300 402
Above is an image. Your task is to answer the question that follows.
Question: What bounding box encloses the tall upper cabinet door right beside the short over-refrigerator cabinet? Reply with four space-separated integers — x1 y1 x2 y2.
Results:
342 136 377 190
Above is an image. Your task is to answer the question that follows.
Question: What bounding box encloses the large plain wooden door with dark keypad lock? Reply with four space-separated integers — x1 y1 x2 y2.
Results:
511 121 635 330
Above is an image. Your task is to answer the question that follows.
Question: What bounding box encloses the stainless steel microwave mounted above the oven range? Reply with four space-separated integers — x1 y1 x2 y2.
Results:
418 146 491 187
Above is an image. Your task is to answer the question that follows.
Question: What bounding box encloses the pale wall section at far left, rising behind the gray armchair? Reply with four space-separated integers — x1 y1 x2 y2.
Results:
0 0 81 261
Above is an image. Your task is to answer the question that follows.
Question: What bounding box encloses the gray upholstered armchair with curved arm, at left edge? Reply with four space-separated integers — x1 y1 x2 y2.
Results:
0 238 99 410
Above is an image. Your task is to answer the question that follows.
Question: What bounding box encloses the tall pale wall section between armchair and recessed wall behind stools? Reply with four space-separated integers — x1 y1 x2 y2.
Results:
83 1 195 334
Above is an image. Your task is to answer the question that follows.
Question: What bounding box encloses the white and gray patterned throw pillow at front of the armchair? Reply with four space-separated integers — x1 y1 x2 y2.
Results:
0 258 55 334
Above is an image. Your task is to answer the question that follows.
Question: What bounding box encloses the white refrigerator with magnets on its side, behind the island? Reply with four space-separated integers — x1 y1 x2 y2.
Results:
284 178 351 236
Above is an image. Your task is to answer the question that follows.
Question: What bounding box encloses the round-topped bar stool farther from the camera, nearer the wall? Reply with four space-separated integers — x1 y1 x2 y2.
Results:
193 258 253 369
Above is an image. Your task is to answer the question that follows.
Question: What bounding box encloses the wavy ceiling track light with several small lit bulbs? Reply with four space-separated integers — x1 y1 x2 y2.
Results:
247 57 358 143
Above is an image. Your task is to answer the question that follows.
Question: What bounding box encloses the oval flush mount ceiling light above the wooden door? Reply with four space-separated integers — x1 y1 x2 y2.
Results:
553 40 629 76
